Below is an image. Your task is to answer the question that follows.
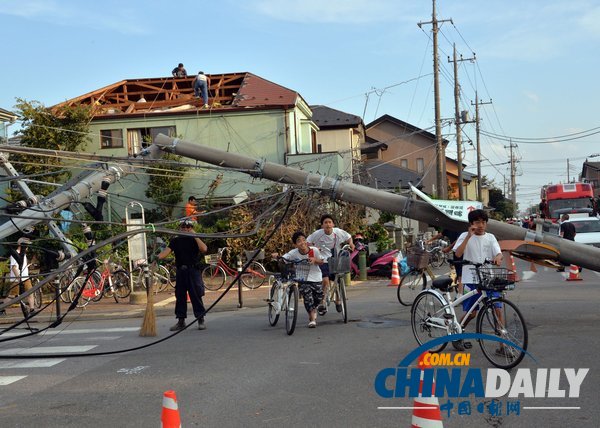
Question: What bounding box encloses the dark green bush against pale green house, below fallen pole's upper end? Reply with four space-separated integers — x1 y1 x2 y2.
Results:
145 153 187 222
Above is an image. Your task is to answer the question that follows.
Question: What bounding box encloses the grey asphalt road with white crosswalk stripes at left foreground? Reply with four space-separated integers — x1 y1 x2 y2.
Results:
0 264 600 427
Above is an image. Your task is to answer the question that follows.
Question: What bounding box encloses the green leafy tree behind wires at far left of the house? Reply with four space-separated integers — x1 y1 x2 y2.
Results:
8 98 92 200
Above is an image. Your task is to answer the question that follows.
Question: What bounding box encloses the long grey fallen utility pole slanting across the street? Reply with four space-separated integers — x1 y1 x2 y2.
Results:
154 134 600 271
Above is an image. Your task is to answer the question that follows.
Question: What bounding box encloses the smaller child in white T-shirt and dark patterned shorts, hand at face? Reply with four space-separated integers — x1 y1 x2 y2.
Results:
283 232 325 328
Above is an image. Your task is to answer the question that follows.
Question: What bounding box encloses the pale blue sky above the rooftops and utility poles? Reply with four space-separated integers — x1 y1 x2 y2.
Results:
0 0 600 211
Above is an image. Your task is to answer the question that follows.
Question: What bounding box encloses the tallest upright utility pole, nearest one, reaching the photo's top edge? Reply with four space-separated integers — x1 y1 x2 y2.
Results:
417 0 452 199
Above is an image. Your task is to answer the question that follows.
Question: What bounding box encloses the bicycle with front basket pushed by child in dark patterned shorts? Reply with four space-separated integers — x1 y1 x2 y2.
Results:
267 258 300 336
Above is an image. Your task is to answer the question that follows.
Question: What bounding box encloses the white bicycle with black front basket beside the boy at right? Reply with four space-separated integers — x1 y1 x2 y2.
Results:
411 261 528 369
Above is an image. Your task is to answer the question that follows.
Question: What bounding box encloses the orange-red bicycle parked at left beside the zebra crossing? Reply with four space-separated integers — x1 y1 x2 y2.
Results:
71 259 131 308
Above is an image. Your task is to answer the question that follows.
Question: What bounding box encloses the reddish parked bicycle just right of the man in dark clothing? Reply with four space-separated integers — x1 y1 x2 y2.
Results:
202 247 267 291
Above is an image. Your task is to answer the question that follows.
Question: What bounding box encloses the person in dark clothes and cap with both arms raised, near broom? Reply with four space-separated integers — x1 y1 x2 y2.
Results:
158 220 208 331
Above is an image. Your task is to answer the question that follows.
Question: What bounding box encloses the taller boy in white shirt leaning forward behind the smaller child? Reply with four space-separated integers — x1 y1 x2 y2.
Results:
306 214 354 315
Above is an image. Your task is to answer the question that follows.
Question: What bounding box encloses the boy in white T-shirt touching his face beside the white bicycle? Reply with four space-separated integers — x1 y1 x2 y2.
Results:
453 210 502 325
